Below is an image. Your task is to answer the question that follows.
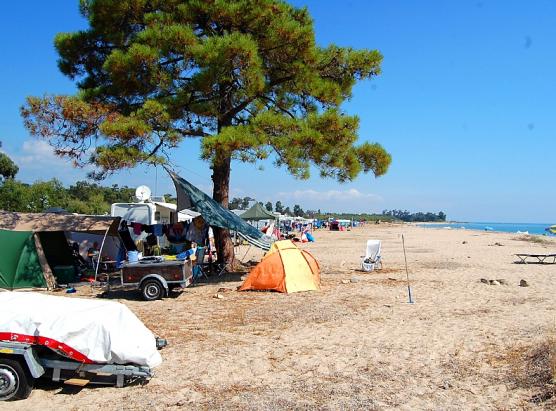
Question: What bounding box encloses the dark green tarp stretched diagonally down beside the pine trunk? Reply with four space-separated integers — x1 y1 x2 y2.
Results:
166 168 270 250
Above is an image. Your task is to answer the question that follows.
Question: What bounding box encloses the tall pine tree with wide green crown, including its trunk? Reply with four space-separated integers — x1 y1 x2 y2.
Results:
22 0 390 262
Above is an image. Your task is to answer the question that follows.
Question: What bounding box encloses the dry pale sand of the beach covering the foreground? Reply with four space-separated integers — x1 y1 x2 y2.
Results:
0 225 556 410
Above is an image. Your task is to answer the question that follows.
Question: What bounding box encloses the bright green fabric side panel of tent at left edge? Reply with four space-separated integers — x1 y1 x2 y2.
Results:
0 230 47 290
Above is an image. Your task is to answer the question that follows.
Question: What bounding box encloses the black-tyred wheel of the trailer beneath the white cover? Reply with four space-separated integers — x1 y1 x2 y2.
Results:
0 358 35 401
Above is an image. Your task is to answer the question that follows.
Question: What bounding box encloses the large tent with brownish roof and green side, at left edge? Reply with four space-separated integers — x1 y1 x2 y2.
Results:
0 211 120 290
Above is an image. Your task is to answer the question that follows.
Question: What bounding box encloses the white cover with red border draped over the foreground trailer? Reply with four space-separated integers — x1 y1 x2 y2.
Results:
0 291 162 368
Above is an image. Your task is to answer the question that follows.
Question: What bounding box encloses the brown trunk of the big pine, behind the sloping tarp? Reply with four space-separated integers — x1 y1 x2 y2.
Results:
212 150 234 267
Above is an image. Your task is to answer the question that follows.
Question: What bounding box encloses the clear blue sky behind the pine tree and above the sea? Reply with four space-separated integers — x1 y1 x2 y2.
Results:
0 0 556 223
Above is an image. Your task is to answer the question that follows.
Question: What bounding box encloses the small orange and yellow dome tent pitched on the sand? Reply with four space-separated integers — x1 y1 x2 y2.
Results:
239 240 320 293
